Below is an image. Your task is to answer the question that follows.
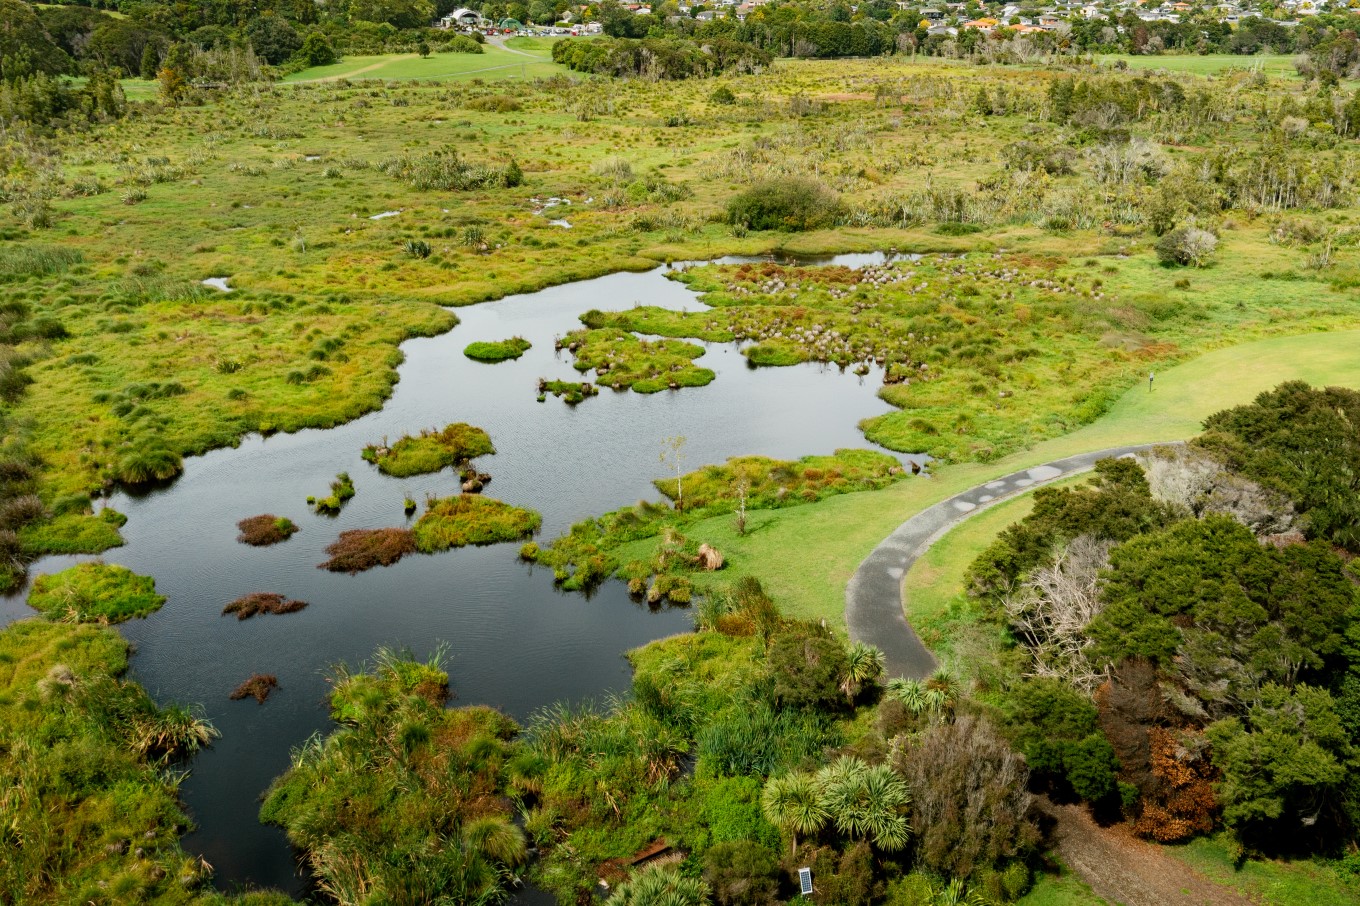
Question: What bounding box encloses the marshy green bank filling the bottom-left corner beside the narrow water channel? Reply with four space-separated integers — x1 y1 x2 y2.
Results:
0 620 222 906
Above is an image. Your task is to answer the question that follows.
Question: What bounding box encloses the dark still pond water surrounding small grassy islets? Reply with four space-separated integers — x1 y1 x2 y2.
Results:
10 256 908 891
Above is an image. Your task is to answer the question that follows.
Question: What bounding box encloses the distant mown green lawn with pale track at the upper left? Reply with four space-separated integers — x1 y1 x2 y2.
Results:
283 47 568 83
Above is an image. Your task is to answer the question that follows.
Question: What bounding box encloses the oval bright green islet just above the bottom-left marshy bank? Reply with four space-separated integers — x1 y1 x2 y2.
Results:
29 563 166 623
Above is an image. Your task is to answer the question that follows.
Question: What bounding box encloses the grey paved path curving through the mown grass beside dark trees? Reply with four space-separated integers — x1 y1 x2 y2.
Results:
846 442 1167 679
